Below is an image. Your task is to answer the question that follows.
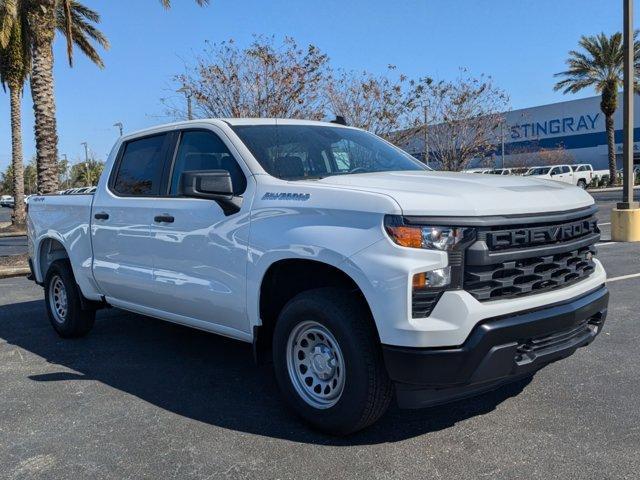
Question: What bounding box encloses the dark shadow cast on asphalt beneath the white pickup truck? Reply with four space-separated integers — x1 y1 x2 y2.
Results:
0 301 530 445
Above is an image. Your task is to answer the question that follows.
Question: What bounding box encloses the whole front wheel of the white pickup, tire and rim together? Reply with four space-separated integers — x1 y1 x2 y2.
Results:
273 288 393 435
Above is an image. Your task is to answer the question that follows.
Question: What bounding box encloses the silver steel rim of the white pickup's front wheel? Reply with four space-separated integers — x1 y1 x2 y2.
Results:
287 321 346 409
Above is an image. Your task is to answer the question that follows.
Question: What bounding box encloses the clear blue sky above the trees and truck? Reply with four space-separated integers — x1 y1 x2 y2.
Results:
0 0 640 170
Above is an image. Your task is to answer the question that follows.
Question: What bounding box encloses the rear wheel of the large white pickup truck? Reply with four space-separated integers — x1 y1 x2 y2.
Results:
44 260 96 338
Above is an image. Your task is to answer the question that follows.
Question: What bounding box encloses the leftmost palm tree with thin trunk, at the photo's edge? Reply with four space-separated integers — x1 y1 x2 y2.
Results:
0 2 31 227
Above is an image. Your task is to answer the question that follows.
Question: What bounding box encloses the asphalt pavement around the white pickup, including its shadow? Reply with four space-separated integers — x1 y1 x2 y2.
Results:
0 196 640 480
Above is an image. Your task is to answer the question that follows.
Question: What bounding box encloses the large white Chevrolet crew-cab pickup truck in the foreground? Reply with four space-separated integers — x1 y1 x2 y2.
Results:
28 119 608 434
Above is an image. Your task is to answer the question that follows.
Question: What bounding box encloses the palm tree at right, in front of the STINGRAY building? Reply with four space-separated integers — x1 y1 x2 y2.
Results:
554 32 640 185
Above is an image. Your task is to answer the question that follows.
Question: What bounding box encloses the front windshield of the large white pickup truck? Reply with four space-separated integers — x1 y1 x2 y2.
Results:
233 125 430 180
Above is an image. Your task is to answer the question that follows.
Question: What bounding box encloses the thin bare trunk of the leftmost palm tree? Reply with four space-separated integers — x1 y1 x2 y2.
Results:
9 85 25 226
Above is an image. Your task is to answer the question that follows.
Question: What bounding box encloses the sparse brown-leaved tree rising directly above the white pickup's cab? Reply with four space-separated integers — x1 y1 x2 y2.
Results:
165 37 328 119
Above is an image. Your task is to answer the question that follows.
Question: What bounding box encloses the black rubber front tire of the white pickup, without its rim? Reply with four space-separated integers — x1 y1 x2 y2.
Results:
273 288 393 435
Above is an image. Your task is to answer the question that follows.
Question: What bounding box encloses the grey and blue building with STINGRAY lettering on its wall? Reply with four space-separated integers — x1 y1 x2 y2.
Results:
411 94 640 170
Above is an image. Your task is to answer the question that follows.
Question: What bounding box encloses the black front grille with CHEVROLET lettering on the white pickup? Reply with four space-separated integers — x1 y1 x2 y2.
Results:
464 210 600 301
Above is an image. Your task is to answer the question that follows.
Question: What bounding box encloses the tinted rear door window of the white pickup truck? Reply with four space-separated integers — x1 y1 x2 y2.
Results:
112 134 167 197
